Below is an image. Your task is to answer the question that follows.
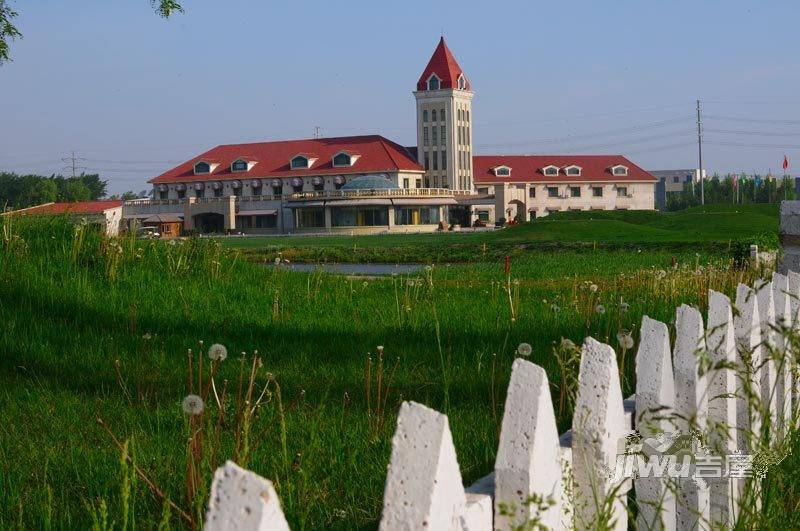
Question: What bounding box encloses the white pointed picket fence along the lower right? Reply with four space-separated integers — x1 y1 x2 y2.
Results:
206 272 800 531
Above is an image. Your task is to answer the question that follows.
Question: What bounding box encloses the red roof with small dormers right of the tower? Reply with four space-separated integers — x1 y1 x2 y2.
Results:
472 155 657 184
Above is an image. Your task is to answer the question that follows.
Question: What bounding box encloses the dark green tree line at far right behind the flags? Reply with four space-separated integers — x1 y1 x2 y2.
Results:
666 174 796 211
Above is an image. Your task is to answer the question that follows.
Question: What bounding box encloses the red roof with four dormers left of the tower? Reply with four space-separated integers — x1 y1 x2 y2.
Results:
148 135 424 184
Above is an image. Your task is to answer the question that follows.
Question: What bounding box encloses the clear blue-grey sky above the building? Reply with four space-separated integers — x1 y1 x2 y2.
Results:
0 0 800 193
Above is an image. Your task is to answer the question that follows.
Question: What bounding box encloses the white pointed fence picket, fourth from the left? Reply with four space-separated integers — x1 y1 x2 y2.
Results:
572 337 630 530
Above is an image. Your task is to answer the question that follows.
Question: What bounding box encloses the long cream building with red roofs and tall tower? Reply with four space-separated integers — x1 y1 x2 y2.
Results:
124 38 656 234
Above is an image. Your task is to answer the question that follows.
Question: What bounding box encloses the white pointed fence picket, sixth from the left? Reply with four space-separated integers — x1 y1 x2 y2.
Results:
674 304 711 529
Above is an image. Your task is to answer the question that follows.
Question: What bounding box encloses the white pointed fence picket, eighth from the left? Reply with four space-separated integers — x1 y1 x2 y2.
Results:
733 284 761 454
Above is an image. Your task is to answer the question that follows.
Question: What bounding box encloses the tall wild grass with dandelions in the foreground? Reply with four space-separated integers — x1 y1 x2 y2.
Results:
0 210 800 529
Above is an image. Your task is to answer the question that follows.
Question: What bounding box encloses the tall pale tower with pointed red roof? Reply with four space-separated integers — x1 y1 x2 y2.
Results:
414 37 473 190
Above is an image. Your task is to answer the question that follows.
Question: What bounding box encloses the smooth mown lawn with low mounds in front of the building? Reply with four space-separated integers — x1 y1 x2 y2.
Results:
220 204 778 263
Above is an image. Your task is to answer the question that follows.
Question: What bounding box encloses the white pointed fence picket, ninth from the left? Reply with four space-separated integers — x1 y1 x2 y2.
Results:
753 280 778 441
